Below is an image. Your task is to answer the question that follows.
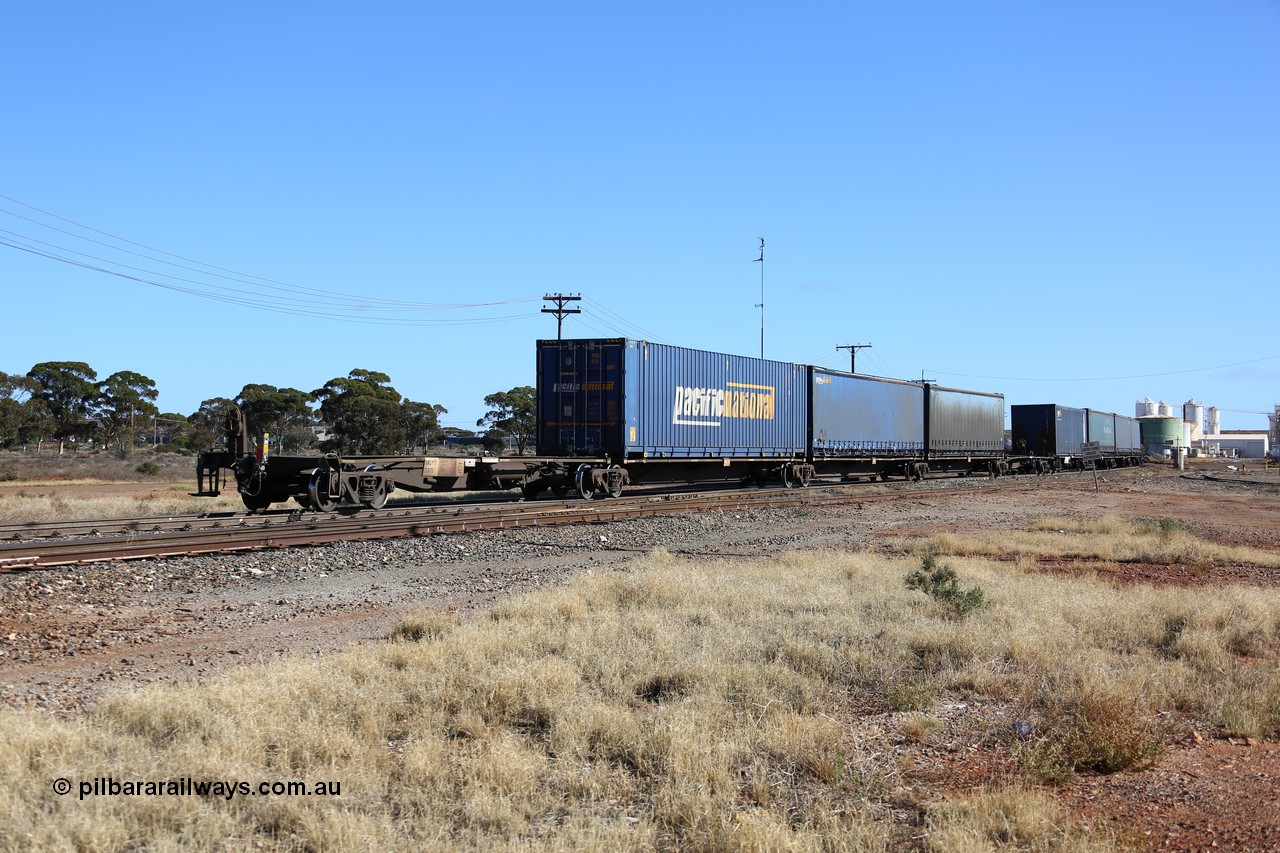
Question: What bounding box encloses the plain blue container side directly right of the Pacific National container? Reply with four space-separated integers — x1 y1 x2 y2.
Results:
809 368 924 457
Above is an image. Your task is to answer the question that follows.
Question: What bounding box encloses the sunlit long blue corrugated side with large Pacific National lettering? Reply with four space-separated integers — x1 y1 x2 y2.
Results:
625 341 809 459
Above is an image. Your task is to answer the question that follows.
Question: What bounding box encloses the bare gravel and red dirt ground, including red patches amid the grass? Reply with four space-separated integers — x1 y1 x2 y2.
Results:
0 466 1280 849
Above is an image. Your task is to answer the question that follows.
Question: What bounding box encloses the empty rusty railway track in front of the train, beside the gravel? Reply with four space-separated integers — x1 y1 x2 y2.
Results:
0 474 1085 573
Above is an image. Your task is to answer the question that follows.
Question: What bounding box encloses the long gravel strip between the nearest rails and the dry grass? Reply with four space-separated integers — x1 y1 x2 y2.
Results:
0 467 1264 711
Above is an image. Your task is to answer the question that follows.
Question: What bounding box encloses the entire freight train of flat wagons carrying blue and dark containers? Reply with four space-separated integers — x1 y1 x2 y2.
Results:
198 338 1142 511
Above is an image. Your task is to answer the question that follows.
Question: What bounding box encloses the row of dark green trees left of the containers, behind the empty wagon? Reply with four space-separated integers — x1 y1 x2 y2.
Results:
0 361 536 456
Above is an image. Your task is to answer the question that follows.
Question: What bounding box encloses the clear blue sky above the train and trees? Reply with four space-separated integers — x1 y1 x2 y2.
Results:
0 0 1280 428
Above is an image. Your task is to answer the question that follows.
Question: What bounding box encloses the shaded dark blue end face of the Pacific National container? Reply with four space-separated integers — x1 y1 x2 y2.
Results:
538 338 626 457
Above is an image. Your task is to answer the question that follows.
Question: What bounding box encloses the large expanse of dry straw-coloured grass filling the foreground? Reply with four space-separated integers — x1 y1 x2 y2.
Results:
0 537 1280 850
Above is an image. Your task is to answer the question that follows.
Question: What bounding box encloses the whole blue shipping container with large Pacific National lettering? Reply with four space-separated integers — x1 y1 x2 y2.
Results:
538 338 808 461
